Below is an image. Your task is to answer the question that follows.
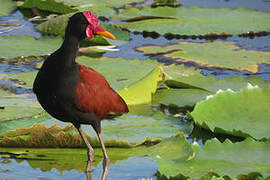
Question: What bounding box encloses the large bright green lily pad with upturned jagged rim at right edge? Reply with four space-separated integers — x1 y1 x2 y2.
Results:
191 85 270 139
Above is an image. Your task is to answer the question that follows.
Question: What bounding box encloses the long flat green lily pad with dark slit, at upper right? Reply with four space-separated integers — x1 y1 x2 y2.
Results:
114 7 270 35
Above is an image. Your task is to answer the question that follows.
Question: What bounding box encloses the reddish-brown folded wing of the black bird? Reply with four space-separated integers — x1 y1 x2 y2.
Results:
75 64 128 118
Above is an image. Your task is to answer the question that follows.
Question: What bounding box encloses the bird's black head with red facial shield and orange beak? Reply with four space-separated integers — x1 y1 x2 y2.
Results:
66 11 115 40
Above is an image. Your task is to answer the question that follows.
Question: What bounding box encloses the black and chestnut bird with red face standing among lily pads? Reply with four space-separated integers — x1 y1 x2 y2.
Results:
33 11 129 180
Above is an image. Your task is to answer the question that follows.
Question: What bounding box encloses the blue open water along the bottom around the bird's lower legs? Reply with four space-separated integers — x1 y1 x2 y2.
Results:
0 157 158 180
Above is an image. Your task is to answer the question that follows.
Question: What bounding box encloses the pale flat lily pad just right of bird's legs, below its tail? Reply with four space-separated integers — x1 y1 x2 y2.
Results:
102 112 193 144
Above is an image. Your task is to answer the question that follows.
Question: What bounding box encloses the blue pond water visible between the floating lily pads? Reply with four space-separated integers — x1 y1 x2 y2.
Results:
0 0 270 180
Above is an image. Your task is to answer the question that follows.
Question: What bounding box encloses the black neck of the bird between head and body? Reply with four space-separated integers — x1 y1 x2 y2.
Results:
59 34 80 66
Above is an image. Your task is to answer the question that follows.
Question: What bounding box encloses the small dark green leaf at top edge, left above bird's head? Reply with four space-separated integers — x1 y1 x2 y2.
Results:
20 0 77 14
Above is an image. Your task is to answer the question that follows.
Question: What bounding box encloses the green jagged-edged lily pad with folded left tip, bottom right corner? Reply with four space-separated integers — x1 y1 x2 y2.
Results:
145 135 270 179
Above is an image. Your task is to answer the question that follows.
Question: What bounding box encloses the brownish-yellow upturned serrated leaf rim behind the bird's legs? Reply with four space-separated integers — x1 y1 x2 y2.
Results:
0 124 132 148
